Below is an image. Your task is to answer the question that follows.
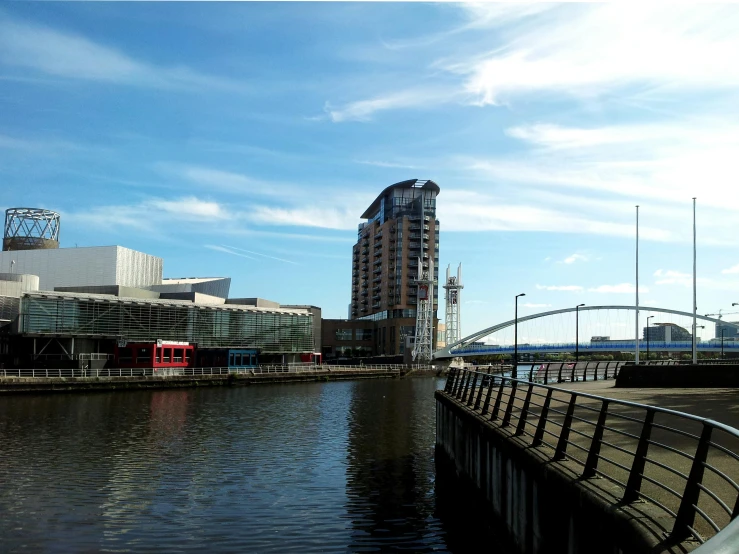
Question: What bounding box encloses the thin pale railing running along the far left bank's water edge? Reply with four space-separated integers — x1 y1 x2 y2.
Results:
0 363 422 378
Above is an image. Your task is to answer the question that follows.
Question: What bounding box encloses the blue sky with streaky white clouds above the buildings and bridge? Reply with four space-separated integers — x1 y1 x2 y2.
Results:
0 2 739 338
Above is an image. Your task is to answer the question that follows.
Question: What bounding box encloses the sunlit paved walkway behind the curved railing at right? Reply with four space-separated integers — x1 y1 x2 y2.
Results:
528 379 739 537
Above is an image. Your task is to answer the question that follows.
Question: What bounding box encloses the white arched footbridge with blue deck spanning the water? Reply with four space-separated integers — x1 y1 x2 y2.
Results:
433 306 739 359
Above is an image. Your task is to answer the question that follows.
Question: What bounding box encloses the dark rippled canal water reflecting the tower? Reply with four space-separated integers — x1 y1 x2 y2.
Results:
0 378 504 554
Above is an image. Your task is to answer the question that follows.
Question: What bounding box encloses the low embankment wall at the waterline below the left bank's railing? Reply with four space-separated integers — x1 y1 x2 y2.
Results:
0 369 400 394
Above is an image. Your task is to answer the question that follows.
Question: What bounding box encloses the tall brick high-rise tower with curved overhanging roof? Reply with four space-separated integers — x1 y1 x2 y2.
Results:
349 179 439 355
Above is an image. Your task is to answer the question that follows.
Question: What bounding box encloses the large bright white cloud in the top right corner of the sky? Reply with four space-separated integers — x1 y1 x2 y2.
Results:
450 3 739 105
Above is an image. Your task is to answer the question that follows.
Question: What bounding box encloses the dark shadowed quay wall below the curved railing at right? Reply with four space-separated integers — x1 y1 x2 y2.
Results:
436 391 670 554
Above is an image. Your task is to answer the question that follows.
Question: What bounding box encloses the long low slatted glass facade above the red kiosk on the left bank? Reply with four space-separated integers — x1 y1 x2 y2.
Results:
20 292 314 353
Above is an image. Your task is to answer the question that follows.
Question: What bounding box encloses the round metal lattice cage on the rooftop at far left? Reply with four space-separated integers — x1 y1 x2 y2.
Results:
3 208 61 252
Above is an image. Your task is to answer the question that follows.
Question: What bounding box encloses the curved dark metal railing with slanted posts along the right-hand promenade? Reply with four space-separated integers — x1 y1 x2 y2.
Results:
444 369 739 552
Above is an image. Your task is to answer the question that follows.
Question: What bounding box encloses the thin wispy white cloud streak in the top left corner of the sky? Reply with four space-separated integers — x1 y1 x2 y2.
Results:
0 14 236 90
